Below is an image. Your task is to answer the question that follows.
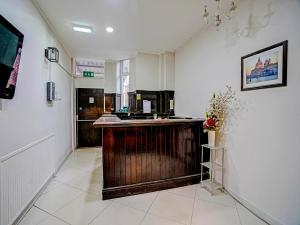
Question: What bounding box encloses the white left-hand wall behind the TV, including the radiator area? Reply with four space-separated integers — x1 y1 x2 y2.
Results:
0 0 72 225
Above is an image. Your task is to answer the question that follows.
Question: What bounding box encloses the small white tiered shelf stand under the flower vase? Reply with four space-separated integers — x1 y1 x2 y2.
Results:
200 144 225 195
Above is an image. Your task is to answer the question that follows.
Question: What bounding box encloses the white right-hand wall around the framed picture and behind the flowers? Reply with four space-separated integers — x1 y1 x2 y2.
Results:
175 0 300 225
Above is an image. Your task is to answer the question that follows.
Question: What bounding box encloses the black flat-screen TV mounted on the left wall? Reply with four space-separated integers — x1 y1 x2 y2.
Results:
0 15 24 99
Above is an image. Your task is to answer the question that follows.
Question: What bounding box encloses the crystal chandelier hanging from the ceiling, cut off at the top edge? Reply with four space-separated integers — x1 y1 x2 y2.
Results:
203 0 237 30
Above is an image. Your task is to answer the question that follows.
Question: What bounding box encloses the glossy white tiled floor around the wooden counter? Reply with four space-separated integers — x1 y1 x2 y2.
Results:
20 148 266 225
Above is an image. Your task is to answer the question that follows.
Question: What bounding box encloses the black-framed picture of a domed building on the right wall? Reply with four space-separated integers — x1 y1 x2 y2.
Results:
241 41 288 91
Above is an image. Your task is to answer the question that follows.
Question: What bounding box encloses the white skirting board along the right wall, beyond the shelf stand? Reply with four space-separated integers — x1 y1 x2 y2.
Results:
225 188 283 225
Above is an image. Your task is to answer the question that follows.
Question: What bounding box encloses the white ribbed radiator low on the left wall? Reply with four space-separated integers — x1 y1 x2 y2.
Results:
0 134 55 225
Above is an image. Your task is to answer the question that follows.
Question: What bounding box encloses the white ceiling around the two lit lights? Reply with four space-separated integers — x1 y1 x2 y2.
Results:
33 0 227 60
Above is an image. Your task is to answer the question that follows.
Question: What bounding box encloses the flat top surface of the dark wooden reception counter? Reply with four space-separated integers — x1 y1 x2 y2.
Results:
93 114 203 128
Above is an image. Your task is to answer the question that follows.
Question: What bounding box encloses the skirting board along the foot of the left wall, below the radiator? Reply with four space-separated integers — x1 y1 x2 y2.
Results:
11 151 72 225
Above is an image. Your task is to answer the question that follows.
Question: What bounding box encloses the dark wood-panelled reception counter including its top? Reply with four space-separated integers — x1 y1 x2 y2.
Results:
94 114 207 199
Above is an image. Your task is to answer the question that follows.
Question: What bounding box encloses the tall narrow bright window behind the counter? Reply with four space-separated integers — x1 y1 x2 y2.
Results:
120 59 130 107
